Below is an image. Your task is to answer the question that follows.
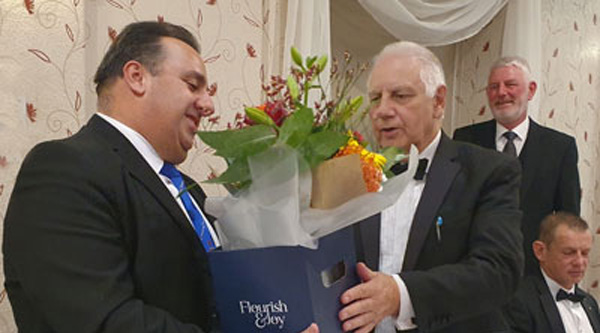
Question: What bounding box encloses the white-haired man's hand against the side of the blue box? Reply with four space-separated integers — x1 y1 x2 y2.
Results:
339 263 400 333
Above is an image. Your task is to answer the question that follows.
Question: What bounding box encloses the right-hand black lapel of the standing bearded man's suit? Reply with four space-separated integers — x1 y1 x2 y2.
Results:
519 118 544 198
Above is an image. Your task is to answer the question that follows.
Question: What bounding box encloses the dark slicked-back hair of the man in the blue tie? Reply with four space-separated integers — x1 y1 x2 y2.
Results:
94 21 200 95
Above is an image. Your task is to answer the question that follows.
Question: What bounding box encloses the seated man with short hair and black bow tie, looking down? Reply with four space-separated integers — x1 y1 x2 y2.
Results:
505 212 600 333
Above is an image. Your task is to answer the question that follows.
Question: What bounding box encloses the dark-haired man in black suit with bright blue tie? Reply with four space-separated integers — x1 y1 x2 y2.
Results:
3 22 314 333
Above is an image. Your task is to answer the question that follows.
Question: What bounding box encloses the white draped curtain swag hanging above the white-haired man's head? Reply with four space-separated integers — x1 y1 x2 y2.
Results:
358 0 508 46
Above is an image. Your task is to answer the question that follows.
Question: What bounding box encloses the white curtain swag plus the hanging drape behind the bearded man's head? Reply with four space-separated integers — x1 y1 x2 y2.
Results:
358 0 542 118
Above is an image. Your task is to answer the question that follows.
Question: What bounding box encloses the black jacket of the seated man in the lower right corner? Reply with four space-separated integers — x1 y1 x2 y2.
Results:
505 275 600 333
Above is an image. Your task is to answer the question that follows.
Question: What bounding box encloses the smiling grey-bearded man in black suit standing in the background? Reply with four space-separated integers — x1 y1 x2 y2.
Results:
454 57 581 275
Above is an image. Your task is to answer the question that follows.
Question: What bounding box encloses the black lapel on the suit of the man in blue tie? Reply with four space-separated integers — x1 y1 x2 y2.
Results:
88 115 203 250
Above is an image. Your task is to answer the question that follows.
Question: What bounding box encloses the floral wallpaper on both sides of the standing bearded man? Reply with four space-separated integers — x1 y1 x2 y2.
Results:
453 0 600 298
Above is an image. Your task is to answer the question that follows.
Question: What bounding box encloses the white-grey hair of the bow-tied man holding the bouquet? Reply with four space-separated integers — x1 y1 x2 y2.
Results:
367 41 446 97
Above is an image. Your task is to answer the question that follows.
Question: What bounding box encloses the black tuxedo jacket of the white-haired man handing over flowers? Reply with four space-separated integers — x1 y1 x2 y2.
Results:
356 134 523 333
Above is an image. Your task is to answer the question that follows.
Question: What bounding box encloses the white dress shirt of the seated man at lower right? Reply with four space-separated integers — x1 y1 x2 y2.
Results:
542 269 594 333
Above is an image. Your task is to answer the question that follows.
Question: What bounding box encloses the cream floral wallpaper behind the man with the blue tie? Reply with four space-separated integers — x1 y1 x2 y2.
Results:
0 0 268 333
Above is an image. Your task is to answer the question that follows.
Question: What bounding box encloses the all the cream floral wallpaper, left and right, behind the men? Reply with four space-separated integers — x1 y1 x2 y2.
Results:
0 0 600 333
